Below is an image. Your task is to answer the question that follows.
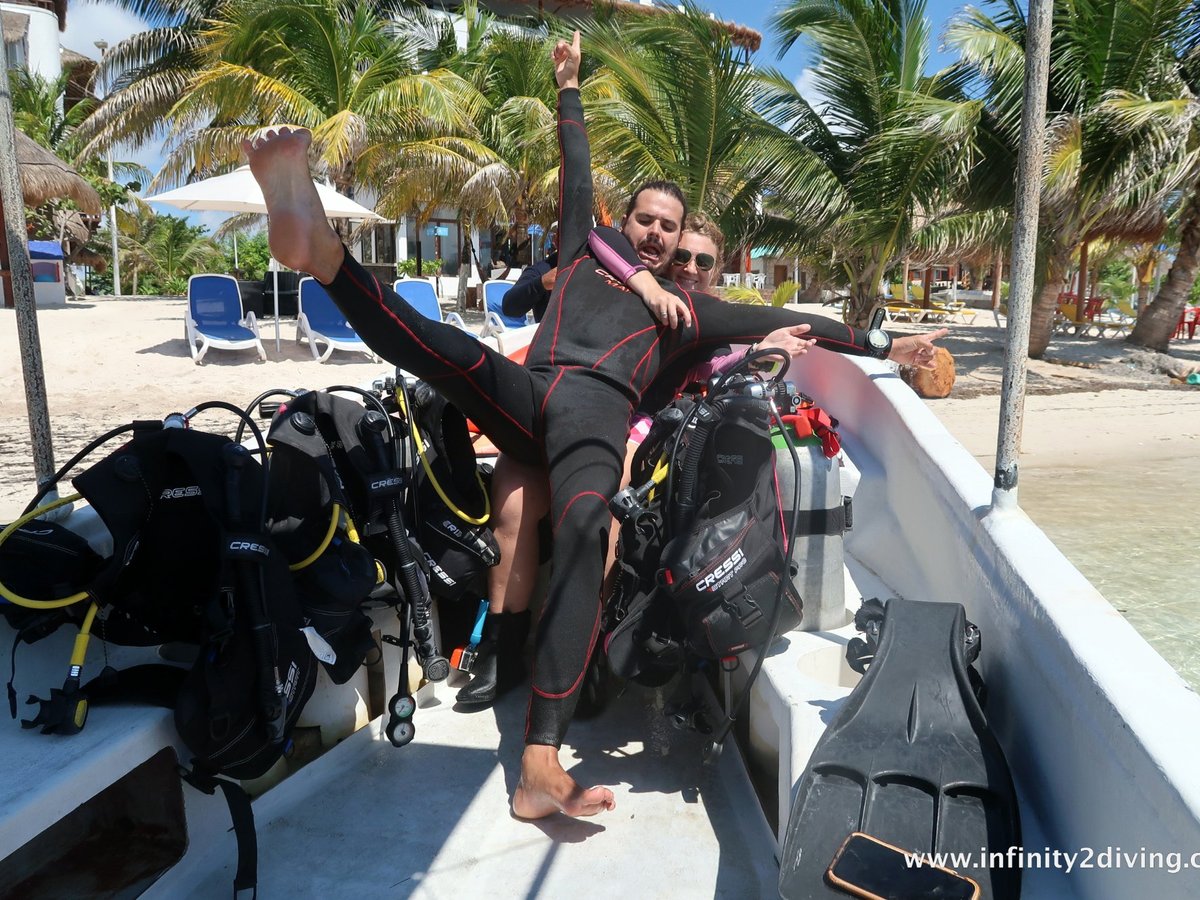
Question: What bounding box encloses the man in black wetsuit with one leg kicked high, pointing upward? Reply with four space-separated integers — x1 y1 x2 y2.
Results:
244 34 934 818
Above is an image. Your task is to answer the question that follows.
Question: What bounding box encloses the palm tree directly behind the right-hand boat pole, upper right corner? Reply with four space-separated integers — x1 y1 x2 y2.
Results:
947 0 1190 358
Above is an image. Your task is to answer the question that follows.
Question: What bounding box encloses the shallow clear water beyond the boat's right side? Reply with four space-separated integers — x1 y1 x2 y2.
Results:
1019 456 1200 690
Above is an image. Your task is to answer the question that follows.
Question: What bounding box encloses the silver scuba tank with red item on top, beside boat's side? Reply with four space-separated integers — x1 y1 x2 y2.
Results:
772 408 851 631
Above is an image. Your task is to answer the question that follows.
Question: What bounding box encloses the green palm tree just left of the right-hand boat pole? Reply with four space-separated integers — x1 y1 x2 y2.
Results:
751 0 983 324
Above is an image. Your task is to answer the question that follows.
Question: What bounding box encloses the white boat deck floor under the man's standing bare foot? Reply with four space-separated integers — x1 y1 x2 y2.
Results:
146 686 779 898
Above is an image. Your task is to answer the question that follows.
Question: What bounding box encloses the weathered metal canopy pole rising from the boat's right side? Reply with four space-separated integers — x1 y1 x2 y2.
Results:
991 0 1054 509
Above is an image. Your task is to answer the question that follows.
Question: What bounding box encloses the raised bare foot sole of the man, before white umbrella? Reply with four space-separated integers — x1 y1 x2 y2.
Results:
241 125 343 284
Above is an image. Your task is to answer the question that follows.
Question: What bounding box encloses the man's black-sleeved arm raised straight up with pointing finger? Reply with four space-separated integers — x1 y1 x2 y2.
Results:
552 31 593 268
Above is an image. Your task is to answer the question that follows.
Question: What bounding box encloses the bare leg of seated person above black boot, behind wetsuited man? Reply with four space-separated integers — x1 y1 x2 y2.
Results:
487 454 550 613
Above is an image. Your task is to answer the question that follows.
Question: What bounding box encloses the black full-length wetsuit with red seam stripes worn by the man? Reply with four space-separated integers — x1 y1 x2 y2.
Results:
329 89 865 746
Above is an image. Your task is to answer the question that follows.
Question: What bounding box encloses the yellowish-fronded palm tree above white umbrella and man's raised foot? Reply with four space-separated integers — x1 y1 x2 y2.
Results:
76 0 474 199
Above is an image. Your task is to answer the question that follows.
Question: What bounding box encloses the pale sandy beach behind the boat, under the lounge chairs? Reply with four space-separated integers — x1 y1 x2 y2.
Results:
0 299 1200 522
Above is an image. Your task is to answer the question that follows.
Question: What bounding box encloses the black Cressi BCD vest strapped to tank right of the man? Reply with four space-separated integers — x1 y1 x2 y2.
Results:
605 354 832 684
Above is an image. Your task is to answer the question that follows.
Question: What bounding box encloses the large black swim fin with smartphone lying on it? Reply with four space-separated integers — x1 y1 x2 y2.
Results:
779 599 1020 900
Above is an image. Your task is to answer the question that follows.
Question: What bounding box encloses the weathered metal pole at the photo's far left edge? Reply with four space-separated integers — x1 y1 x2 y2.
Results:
0 66 54 486
